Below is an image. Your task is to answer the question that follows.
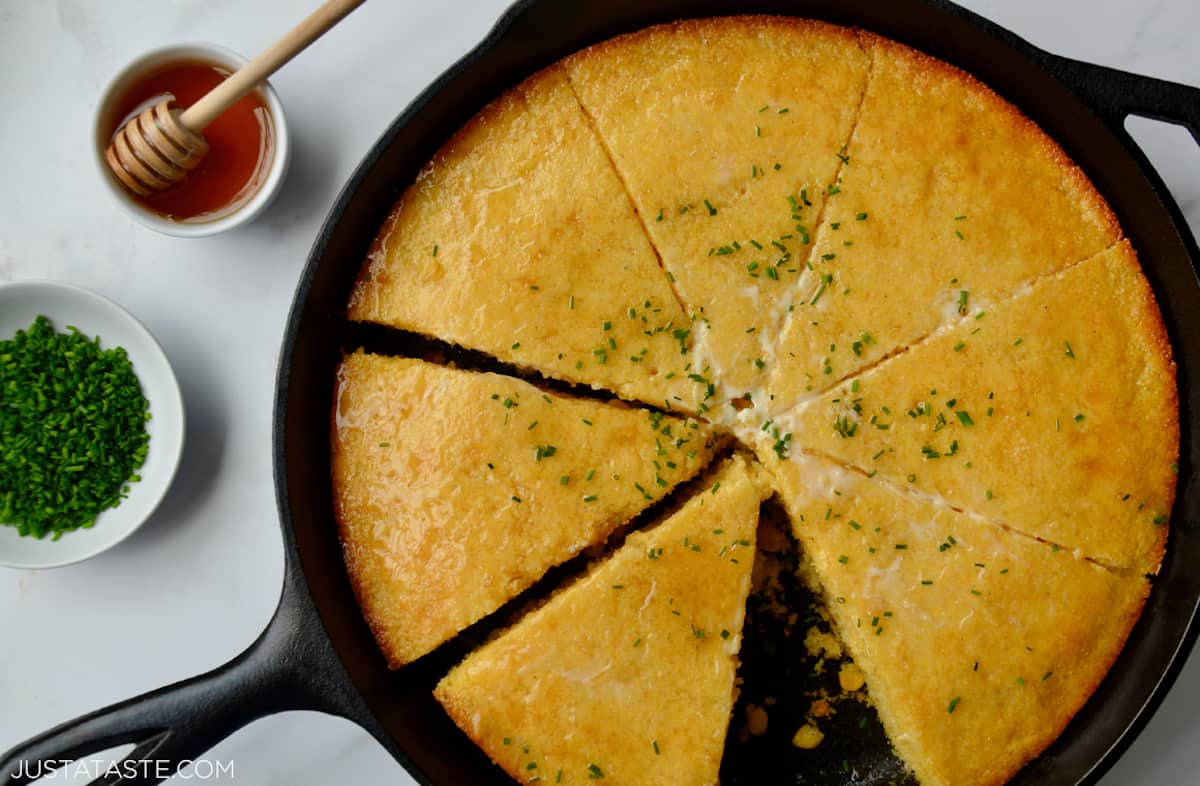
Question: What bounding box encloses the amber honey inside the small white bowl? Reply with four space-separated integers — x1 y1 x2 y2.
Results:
110 60 275 223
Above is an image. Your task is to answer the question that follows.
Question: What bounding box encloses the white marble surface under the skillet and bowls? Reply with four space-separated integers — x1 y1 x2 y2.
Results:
0 0 1200 786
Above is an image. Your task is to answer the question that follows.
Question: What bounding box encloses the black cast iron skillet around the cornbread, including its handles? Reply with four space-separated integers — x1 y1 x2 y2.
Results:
0 0 1200 786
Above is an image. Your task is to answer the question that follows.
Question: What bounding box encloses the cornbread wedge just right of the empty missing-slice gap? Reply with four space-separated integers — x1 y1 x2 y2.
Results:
767 448 1150 786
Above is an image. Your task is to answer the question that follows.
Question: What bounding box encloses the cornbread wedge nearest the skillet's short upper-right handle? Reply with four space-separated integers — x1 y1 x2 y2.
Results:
769 34 1120 407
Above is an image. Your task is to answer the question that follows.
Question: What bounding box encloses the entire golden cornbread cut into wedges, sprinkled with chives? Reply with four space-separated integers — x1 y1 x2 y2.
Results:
343 17 1180 786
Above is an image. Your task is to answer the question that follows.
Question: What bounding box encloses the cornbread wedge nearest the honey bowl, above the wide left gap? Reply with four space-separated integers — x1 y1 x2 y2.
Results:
349 67 703 410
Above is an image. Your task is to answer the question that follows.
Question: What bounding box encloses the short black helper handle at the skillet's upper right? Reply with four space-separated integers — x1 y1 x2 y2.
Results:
1046 55 1200 144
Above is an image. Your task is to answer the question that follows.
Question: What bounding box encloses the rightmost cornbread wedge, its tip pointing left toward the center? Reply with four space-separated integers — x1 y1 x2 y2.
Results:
772 242 1180 574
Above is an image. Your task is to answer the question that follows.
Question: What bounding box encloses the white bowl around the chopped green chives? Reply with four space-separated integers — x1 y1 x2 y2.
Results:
0 281 184 568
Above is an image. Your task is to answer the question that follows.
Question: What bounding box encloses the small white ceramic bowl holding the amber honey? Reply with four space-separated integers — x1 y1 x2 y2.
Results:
92 43 292 238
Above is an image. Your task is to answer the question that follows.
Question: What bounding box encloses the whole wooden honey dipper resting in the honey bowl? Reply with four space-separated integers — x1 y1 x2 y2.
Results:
104 0 365 197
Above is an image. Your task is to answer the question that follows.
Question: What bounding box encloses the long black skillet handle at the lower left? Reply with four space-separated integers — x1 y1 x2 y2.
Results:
0 578 356 786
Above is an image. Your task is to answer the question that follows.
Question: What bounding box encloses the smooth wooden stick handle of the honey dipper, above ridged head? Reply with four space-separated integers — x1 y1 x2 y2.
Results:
179 0 365 133
